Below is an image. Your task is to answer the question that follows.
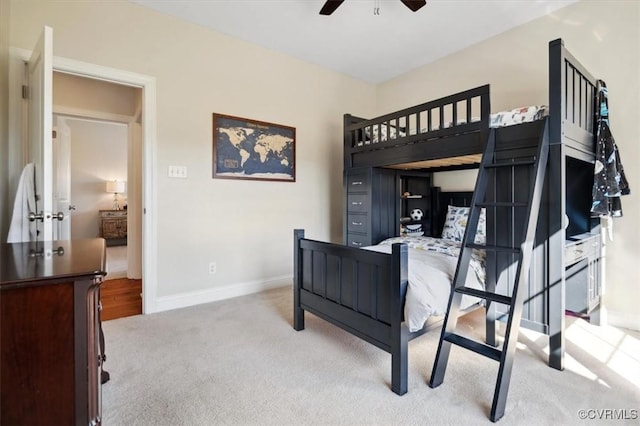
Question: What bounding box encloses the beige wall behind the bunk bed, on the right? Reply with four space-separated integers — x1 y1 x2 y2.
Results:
377 1 640 329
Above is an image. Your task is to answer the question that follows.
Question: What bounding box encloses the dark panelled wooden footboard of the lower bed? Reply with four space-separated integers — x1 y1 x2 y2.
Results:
293 229 409 395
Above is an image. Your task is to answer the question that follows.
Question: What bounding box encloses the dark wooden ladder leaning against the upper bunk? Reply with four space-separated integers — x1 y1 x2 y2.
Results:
429 119 549 422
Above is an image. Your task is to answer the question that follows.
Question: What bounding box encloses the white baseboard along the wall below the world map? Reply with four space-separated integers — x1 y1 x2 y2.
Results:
155 275 293 312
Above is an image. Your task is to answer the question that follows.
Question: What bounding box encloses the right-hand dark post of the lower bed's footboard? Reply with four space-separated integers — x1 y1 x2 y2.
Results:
390 244 409 395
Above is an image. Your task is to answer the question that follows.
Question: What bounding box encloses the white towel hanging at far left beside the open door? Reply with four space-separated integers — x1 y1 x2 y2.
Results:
7 163 36 243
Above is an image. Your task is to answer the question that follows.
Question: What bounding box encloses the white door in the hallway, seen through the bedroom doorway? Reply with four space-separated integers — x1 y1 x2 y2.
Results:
52 116 75 240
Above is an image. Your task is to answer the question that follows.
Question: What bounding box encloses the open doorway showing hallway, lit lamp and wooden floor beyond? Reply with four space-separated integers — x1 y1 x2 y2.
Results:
53 72 143 320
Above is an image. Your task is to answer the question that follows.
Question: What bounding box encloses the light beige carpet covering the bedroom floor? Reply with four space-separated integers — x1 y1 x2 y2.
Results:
102 288 640 426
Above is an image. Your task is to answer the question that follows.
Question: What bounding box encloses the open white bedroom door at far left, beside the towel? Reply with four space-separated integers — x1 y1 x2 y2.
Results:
27 27 53 241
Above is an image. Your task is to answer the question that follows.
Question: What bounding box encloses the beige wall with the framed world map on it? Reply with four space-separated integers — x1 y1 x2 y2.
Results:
11 0 375 297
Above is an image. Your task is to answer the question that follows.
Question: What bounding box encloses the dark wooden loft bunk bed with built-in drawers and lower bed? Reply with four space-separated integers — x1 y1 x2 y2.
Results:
293 39 600 395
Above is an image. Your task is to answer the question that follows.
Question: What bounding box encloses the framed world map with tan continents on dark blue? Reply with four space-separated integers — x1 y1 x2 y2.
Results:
213 113 296 182
